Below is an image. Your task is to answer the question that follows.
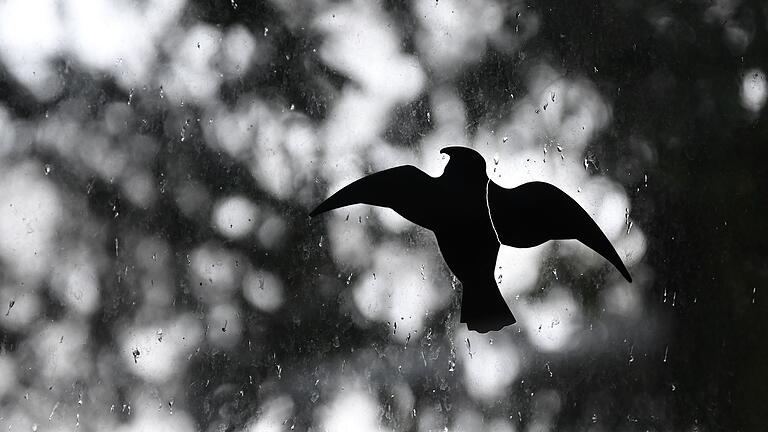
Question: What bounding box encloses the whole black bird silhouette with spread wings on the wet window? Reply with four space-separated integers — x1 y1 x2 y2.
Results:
310 146 632 333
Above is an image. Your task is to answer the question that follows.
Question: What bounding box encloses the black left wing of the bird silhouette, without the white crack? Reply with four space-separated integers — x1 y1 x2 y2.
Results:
309 165 439 229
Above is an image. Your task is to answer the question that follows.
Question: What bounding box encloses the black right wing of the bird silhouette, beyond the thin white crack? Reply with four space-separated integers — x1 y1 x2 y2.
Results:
488 182 632 282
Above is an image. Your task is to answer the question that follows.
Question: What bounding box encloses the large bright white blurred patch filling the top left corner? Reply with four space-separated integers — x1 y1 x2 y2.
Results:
0 0 185 100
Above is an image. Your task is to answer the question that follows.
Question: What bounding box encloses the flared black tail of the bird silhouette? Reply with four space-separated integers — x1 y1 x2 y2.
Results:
459 273 517 333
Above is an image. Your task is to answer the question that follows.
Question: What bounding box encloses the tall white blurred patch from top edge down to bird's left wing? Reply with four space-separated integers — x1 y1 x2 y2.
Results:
315 2 425 190
